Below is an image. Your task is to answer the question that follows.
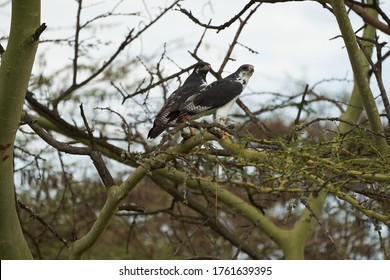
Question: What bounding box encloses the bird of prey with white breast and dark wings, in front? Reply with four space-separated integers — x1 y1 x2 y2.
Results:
168 64 254 124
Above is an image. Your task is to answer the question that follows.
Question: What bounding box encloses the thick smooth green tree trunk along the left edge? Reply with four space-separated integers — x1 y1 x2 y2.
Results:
0 0 41 259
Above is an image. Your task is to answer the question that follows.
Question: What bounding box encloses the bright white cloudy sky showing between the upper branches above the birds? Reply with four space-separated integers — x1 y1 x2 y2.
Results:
0 0 390 121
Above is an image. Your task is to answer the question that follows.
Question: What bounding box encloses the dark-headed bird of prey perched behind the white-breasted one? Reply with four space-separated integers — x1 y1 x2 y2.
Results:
148 62 211 138
